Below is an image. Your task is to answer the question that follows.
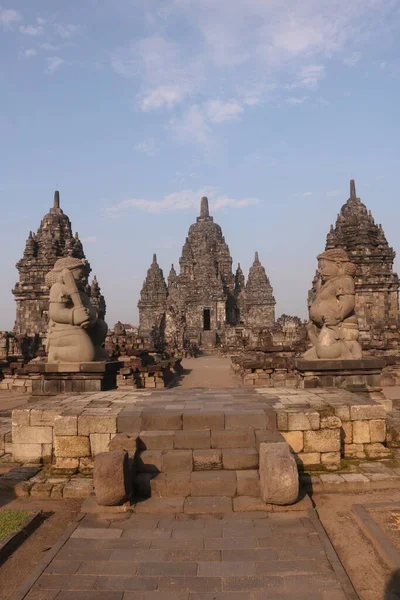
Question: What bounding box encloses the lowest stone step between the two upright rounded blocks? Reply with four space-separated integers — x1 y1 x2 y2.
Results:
148 469 260 498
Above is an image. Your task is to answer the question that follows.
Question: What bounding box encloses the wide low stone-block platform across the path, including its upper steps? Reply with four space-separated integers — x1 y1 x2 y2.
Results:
12 388 390 478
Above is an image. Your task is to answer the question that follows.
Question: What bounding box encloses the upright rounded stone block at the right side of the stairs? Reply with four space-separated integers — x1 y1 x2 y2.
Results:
259 440 298 505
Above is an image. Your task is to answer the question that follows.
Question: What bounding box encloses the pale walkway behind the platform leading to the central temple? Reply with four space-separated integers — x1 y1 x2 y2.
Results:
179 354 242 388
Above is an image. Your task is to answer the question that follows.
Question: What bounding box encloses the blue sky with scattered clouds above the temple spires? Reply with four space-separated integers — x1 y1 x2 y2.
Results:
0 0 400 329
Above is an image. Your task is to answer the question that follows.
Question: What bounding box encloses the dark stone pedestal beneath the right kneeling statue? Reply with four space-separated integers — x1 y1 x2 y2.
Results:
294 358 386 392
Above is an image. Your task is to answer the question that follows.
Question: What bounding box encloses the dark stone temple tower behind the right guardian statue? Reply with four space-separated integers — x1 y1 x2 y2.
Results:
326 180 400 350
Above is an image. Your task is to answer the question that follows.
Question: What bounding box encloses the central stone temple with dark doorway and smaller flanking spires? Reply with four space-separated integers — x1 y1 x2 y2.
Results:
138 198 275 346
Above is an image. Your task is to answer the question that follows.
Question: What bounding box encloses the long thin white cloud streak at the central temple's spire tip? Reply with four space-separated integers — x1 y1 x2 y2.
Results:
106 186 260 218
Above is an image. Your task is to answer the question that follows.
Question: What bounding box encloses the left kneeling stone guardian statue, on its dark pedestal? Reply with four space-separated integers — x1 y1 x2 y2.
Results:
46 257 109 363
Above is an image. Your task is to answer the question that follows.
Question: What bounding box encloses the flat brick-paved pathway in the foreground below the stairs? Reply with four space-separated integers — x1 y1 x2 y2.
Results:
18 510 357 600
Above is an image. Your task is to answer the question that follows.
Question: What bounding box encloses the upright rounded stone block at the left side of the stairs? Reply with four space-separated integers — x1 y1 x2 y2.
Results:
93 450 133 506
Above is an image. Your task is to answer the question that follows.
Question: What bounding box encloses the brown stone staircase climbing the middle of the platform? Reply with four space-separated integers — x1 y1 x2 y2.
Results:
110 407 283 502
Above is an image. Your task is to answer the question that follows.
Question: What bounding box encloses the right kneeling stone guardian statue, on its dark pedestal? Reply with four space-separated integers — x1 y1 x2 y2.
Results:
303 248 362 360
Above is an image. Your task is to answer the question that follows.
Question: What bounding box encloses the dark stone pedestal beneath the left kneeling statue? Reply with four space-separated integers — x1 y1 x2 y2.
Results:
25 361 122 396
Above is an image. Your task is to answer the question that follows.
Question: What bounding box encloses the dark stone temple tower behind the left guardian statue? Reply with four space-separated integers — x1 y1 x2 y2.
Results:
13 191 106 338
